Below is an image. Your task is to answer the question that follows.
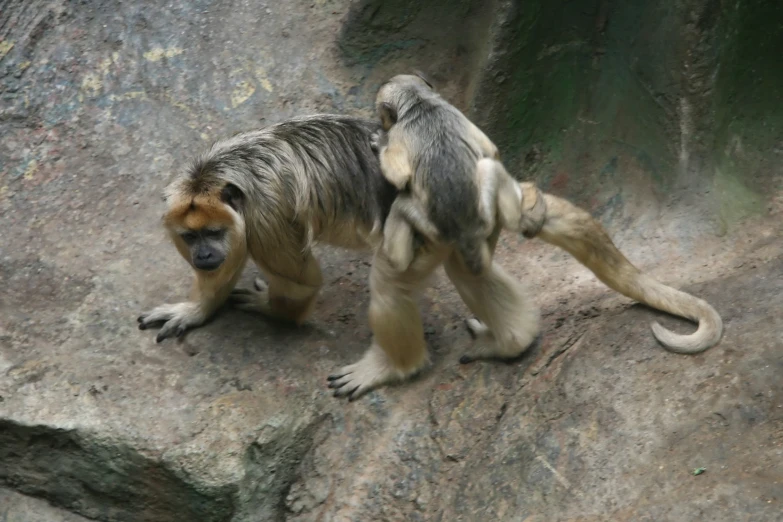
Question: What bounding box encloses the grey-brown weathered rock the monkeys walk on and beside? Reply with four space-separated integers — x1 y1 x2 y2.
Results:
0 0 783 522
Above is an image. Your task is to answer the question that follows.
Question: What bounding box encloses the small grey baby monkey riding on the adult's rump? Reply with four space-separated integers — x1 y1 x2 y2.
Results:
373 74 545 275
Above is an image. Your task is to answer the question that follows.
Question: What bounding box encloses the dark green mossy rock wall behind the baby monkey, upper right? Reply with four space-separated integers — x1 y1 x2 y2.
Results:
340 0 783 231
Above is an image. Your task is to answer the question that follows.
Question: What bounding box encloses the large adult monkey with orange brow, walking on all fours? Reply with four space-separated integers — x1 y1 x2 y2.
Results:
139 115 720 399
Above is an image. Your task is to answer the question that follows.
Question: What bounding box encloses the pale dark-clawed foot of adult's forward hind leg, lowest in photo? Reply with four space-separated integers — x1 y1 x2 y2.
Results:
327 343 423 401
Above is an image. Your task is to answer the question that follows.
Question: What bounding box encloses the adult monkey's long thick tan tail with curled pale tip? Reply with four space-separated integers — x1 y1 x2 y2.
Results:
537 193 723 354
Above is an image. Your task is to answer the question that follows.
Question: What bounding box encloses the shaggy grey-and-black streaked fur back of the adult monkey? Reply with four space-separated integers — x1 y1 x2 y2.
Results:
178 114 396 250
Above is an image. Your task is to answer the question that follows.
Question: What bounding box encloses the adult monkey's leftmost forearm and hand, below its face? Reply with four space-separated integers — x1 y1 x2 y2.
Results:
137 267 242 343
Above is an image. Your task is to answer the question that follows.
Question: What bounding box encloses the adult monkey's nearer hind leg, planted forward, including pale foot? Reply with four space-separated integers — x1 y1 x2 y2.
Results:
328 246 442 400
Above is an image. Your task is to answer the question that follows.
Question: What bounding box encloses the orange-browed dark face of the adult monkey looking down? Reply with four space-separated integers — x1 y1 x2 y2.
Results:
164 185 245 272
